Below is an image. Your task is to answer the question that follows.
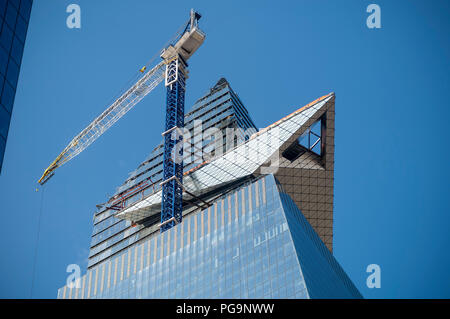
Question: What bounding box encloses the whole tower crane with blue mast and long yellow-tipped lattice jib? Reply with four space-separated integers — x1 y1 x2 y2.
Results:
38 9 206 232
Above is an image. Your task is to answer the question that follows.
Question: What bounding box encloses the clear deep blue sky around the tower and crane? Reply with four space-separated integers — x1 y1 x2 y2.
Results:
0 0 450 298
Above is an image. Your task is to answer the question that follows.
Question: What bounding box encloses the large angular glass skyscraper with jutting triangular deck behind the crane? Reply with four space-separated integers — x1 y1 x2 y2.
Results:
58 79 361 299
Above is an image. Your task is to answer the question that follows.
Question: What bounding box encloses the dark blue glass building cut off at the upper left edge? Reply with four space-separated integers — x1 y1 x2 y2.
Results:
0 0 33 172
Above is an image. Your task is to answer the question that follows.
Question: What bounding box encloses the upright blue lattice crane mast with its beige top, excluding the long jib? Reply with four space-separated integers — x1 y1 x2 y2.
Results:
160 10 205 232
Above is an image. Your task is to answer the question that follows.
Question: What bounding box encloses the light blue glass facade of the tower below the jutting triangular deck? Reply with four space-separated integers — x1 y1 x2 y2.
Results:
58 175 361 299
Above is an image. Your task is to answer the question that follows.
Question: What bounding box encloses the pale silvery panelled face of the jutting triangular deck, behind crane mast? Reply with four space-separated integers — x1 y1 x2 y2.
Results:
116 94 332 222
